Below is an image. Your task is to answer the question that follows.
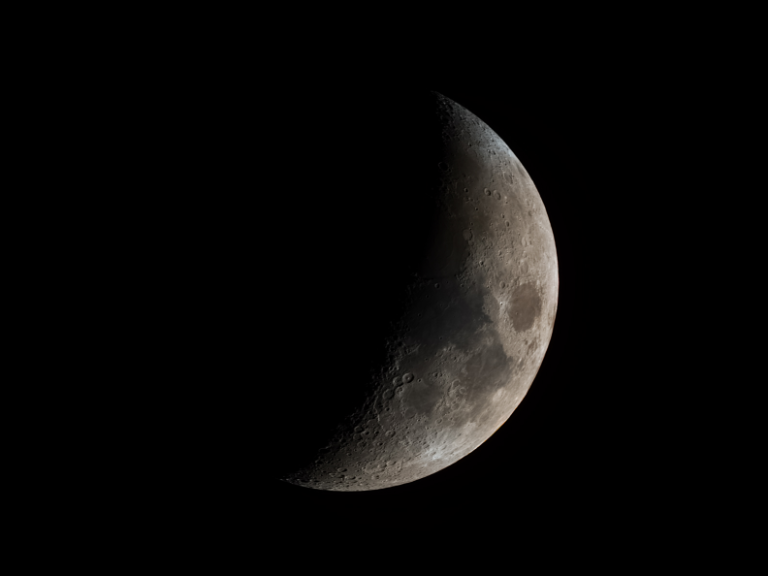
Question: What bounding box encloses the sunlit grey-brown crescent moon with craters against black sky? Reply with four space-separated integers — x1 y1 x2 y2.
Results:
280 92 559 491
